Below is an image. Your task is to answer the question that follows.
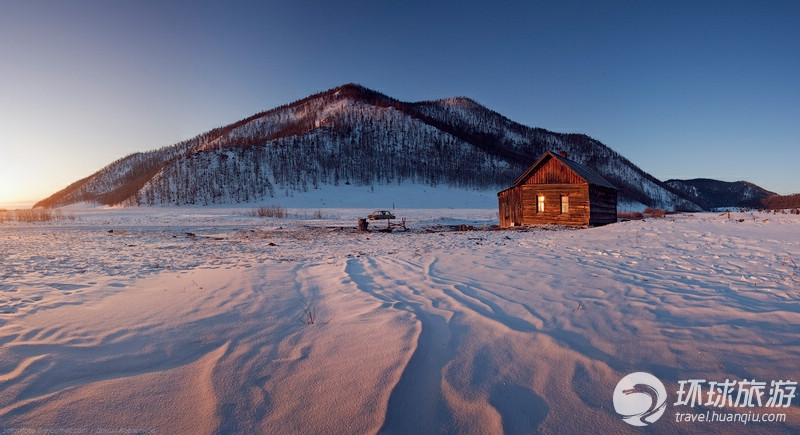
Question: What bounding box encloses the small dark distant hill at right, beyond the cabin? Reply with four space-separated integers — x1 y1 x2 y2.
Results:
666 178 777 209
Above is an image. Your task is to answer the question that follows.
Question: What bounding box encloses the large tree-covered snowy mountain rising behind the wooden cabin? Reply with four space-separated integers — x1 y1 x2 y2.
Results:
36 84 701 210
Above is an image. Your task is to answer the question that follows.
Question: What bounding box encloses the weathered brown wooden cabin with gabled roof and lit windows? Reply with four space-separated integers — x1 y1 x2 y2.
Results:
497 151 617 228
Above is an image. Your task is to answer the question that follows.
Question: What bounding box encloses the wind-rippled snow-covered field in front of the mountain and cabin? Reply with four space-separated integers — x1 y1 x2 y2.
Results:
0 208 800 434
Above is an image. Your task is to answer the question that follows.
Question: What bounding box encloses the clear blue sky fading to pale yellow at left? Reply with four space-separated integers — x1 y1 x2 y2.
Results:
0 0 800 204
